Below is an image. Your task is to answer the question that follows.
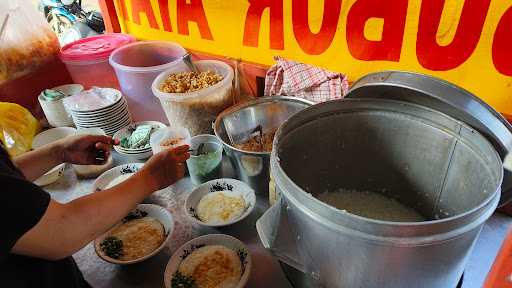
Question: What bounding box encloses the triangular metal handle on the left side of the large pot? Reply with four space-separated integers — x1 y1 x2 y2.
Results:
256 197 306 273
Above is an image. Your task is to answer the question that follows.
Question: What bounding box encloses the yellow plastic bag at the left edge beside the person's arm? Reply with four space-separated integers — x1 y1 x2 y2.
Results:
0 102 41 157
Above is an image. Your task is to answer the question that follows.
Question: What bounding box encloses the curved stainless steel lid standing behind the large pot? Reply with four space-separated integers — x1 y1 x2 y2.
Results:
347 71 512 205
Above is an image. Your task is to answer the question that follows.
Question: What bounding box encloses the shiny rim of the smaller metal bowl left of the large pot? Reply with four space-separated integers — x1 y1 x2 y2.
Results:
212 96 315 156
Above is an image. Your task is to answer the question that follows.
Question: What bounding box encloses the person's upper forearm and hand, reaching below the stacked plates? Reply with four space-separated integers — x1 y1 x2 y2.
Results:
13 135 114 181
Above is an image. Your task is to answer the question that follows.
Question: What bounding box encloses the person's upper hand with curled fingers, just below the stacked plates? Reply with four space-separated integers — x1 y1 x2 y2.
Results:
56 135 117 165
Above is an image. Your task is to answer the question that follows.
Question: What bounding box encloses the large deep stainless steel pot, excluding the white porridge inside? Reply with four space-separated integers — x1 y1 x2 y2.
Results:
257 99 503 288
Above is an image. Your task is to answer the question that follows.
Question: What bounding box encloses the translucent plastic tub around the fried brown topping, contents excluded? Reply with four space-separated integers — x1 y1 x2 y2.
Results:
151 60 233 136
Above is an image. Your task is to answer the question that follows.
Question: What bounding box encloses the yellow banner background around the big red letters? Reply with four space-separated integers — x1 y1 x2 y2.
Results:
115 0 512 115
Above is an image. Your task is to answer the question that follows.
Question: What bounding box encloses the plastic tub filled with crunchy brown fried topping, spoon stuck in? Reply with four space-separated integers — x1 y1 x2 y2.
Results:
151 60 234 136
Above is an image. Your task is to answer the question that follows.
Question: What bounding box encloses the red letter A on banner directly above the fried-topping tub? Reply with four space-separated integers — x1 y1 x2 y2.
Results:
176 0 213 40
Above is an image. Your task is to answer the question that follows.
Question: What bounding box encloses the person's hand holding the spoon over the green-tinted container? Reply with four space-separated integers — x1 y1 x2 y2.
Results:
137 145 190 191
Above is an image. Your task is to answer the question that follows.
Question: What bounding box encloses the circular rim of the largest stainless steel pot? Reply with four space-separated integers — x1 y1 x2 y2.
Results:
270 98 504 227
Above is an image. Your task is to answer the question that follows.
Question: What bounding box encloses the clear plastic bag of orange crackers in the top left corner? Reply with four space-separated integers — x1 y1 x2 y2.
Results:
0 0 60 84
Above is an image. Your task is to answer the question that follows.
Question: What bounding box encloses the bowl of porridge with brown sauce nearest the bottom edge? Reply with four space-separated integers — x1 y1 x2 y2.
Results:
164 234 252 288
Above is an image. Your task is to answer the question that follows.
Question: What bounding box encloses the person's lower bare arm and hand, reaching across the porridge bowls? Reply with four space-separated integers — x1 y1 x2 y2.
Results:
11 146 189 260
